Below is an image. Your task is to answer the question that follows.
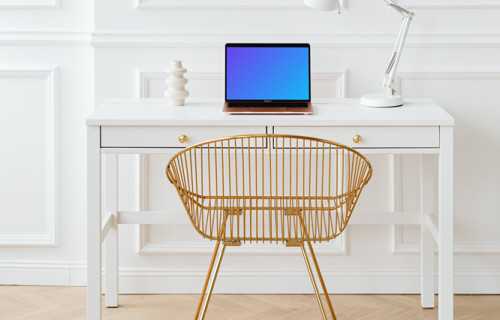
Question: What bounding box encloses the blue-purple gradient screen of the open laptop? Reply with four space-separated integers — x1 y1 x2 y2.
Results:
226 44 311 101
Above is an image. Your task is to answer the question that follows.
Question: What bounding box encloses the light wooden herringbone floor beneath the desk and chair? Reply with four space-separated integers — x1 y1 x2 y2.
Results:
0 286 500 320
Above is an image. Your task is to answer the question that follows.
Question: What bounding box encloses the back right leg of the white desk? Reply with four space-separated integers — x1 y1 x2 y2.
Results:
420 155 435 308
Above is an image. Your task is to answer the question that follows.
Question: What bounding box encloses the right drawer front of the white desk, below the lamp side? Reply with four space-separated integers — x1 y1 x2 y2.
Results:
274 127 439 148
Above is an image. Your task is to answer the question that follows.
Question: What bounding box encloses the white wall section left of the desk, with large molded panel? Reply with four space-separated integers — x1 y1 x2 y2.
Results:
0 0 93 285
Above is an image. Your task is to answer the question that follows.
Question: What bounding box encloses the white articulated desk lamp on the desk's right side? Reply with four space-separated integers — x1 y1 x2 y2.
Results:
303 0 415 108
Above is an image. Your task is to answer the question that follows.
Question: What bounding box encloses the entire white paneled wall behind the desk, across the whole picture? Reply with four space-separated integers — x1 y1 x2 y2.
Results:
0 0 500 293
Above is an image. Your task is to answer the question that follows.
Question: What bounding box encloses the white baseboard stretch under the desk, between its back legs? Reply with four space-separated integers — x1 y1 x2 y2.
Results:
114 267 420 294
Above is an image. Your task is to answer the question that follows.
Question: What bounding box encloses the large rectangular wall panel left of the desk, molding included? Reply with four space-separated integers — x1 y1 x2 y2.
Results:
0 68 59 247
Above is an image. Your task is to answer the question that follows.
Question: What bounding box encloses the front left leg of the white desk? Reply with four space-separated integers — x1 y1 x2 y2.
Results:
87 126 101 320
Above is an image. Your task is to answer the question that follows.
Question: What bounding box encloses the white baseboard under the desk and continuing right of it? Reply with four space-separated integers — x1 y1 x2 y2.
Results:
115 266 500 294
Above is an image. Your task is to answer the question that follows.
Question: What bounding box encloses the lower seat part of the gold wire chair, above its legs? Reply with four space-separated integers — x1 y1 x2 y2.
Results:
182 197 354 243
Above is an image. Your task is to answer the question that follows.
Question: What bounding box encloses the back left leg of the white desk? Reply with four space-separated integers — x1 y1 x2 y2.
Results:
105 154 118 308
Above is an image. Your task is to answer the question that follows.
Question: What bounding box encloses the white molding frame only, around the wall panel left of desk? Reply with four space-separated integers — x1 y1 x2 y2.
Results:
0 66 60 247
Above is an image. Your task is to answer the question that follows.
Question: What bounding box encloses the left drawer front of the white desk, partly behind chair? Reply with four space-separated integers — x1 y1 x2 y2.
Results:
101 126 266 148
